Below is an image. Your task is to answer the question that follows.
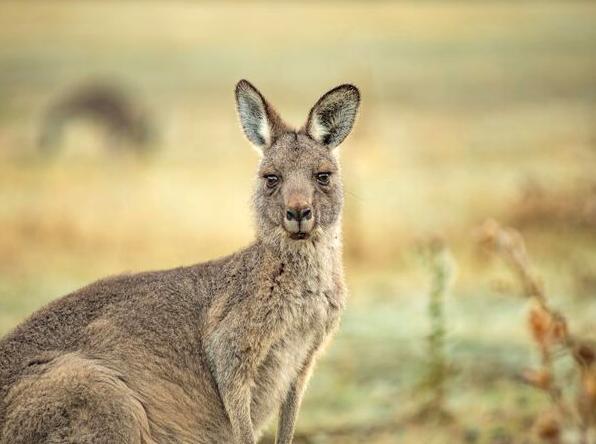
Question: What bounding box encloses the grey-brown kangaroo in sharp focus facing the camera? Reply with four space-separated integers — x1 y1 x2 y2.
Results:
0 80 360 444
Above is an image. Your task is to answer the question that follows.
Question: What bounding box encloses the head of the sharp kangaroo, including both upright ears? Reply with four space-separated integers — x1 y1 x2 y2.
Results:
236 80 360 246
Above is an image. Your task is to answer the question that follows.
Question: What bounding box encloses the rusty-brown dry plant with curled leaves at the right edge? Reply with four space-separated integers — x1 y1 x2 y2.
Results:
479 220 596 444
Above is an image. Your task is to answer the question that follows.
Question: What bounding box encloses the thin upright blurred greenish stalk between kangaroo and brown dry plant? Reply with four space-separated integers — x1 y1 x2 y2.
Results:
418 239 455 421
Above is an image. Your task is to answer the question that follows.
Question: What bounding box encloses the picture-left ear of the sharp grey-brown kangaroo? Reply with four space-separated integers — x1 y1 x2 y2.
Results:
236 80 287 150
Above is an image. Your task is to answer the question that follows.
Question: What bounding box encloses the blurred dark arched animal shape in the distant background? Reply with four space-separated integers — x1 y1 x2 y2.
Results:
38 81 157 156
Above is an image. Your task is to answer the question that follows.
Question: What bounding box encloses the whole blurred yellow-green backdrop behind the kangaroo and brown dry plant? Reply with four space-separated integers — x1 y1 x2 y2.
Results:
0 1 596 444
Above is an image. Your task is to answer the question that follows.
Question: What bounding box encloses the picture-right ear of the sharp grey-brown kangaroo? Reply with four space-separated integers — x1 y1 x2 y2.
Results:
305 85 360 148
